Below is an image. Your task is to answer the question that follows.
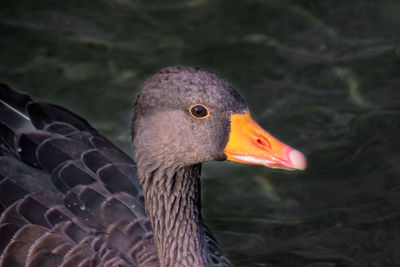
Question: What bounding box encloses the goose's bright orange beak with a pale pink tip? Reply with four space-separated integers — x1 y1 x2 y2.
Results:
224 110 307 170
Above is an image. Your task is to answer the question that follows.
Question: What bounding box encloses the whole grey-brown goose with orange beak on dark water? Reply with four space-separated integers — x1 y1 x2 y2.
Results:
0 67 307 267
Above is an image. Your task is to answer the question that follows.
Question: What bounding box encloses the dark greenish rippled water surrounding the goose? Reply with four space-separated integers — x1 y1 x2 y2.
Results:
0 0 400 267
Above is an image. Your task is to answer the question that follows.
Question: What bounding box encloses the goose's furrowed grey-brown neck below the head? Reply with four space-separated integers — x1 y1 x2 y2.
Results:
138 159 211 266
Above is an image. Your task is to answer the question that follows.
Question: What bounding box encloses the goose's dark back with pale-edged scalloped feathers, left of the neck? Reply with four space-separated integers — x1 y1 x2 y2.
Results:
0 84 157 267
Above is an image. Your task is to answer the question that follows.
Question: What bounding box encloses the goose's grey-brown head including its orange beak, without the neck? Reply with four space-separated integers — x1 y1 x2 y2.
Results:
132 67 306 170
